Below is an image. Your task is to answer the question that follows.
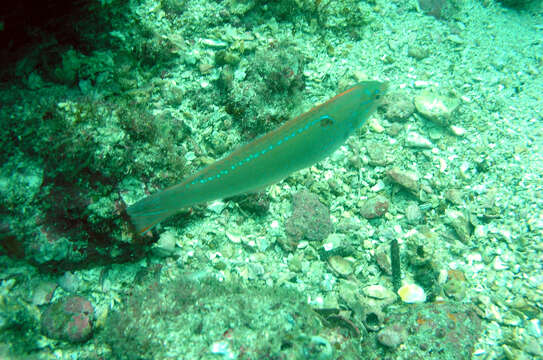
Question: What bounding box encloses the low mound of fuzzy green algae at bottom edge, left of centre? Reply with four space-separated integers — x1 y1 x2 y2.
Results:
100 275 346 360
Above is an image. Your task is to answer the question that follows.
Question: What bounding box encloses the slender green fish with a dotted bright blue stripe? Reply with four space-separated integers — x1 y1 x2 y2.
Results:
126 81 387 234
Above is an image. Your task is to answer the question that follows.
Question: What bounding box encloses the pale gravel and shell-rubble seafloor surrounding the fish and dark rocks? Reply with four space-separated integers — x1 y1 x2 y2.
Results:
0 0 543 359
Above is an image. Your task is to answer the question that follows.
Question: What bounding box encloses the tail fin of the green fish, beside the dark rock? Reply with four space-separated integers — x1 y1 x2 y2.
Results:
126 193 179 235
